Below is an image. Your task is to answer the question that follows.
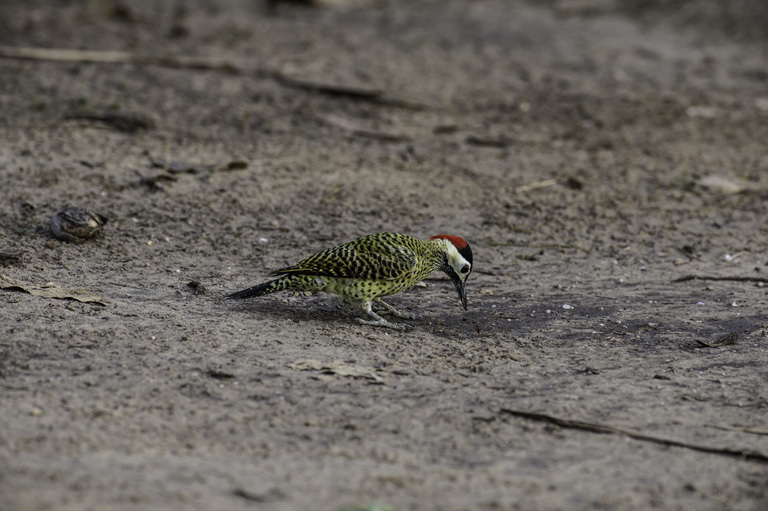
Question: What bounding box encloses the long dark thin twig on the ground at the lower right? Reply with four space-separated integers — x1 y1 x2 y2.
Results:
501 408 768 463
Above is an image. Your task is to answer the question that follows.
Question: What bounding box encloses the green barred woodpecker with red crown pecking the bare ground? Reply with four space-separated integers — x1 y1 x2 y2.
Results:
227 232 472 331
